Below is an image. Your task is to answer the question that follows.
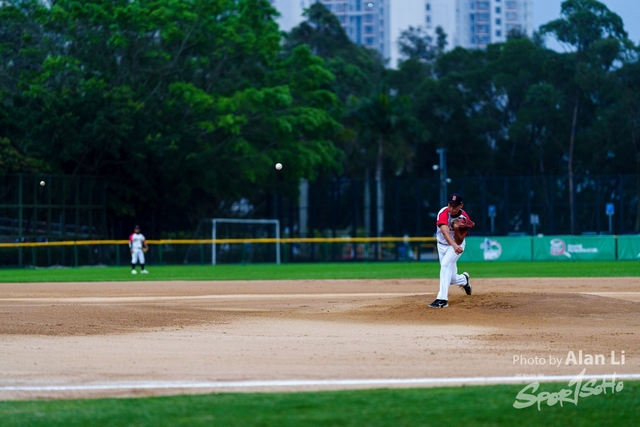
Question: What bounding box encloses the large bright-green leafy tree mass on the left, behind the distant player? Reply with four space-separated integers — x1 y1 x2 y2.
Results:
0 0 341 231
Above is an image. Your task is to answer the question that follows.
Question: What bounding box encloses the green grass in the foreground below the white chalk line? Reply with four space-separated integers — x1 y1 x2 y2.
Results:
0 378 640 427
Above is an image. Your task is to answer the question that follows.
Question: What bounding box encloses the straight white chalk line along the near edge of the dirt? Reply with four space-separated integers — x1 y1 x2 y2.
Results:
0 373 640 392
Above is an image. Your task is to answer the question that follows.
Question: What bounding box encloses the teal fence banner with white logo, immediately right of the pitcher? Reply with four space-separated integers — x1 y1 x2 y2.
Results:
464 236 532 261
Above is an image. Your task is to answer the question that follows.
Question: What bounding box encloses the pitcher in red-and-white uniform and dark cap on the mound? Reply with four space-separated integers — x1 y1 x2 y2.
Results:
429 193 475 308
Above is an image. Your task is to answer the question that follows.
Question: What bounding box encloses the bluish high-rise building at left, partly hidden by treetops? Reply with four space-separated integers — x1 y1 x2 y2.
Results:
270 0 390 58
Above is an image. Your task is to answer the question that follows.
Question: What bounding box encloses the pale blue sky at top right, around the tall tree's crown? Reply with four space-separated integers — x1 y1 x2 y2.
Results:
533 0 640 50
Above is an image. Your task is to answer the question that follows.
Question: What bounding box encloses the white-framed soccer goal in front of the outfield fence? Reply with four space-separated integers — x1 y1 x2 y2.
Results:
211 218 280 265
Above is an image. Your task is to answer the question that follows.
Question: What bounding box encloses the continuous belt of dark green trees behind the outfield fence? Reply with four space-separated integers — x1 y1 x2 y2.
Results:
0 0 640 234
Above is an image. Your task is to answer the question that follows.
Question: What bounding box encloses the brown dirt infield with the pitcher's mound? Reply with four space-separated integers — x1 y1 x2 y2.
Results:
0 278 640 400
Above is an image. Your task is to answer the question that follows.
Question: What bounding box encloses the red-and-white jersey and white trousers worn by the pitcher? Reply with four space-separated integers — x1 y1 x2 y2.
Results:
436 206 471 300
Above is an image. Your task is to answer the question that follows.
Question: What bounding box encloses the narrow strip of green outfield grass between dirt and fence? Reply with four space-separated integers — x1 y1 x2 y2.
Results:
0 261 640 283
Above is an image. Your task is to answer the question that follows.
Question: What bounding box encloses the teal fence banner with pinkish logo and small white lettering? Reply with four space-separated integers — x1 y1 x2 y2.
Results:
533 236 616 261
